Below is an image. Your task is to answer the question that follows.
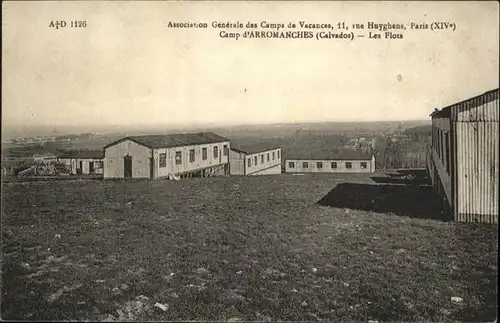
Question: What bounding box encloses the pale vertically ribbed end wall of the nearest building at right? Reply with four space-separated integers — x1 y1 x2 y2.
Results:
452 92 500 223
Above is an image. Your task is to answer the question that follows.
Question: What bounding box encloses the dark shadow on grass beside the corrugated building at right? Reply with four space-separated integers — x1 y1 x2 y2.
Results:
317 183 452 221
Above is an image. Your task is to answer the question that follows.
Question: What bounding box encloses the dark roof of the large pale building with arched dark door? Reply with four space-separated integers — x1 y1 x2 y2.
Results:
104 132 228 148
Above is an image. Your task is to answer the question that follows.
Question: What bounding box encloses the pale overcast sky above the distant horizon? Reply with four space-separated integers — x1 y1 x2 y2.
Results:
2 1 499 125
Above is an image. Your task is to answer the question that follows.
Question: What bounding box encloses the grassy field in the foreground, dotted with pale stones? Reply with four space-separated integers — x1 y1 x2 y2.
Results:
1 174 498 321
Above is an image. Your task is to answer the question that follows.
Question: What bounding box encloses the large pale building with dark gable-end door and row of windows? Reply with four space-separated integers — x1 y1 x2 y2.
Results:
104 132 230 179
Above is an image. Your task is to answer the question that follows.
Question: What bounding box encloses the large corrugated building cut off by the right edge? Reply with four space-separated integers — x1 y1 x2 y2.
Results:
427 89 499 223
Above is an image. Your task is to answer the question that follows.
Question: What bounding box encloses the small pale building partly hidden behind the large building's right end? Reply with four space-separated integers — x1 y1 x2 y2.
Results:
229 143 281 175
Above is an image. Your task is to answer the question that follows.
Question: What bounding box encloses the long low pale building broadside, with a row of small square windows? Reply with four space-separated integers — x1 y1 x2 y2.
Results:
285 150 375 174
